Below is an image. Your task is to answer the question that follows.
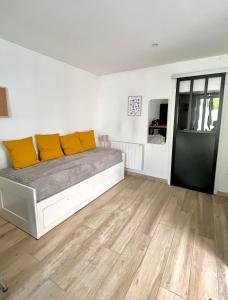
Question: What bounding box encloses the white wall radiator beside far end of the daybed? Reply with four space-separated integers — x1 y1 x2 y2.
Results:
111 141 144 171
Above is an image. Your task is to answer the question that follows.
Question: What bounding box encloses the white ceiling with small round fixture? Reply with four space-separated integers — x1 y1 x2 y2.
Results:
0 0 228 75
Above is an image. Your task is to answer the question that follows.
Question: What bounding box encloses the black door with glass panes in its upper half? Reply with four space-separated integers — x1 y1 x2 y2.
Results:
171 73 225 193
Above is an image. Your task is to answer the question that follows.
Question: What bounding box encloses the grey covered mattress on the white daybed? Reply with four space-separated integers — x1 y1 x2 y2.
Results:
0 148 122 202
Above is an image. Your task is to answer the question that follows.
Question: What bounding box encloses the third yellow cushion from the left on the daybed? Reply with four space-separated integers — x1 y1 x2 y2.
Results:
60 133 83 155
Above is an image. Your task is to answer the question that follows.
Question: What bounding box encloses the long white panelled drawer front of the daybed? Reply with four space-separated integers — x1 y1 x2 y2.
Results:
37 163 124 237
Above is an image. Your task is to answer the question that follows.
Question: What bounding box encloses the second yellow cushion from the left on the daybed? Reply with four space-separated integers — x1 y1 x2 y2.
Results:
35 134 64 161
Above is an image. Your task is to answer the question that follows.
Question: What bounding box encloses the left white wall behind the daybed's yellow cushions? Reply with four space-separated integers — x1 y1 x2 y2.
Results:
0 39 98 168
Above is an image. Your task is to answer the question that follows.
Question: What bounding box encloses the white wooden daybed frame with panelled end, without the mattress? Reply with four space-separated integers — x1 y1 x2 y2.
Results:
0 160 124 239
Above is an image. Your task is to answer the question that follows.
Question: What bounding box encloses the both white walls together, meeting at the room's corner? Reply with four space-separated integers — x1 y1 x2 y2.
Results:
0 39 228 192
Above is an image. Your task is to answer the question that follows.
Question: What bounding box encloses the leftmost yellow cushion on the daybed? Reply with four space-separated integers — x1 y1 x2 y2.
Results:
3 137 40 169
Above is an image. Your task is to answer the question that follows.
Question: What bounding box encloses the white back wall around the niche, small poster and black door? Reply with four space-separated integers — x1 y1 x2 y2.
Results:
99 55 228 192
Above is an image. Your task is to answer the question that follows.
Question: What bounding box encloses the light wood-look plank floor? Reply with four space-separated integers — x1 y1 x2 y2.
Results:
0 176 228 300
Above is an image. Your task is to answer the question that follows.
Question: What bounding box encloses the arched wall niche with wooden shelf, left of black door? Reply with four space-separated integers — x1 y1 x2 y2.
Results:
147 99 168 145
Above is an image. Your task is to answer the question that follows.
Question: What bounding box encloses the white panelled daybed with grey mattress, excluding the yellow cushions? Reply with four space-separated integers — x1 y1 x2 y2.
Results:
0 148 124 239
